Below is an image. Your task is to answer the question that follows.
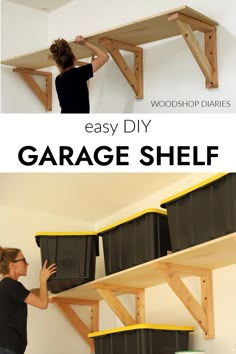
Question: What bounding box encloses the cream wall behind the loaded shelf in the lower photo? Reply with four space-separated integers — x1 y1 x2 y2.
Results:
0 173 236 354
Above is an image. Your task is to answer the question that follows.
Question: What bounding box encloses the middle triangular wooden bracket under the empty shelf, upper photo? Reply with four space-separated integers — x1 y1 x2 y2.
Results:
99 38 143 98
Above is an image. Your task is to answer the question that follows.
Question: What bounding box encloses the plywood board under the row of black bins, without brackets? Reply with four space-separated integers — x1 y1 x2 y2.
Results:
52 233 236 300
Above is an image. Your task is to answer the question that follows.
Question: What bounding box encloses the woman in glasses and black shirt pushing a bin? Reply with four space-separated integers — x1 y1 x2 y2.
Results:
0 247 56 354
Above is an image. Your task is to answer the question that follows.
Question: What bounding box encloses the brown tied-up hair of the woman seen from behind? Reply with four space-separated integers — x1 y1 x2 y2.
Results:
50 38 75 70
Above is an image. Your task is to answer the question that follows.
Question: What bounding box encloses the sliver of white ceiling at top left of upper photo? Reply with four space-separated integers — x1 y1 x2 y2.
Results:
3 0 73 12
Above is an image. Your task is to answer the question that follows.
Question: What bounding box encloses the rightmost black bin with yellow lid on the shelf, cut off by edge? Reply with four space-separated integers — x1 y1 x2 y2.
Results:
161 173 236 251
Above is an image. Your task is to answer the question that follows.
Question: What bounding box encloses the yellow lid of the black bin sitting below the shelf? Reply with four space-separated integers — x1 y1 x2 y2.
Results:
88 323 194 338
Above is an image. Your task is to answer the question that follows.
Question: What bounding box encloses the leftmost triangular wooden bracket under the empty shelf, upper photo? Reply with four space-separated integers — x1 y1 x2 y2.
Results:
13 68 52 111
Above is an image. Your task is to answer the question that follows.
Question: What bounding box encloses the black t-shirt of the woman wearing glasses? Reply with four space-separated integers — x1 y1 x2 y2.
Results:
0 278 30 353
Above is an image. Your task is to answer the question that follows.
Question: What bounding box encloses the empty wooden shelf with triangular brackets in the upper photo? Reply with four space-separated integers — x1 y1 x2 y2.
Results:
1 6 218 110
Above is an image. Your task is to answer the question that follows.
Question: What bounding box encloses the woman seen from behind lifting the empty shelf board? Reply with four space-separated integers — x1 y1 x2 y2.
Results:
50 36 109 113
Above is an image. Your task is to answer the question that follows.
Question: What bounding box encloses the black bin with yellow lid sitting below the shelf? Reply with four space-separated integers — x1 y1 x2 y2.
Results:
89 324 193 354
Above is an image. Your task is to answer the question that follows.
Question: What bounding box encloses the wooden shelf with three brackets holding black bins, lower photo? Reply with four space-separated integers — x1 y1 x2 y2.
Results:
50 233 236 348
